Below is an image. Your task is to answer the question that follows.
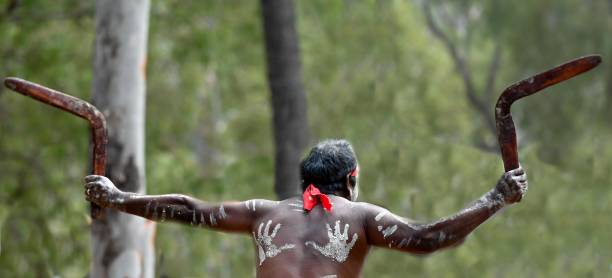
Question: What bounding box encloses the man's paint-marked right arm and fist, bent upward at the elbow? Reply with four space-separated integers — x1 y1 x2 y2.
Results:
365 168 527 254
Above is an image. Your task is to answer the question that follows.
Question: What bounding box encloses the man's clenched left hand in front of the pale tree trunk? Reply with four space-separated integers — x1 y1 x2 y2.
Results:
85 175 126 207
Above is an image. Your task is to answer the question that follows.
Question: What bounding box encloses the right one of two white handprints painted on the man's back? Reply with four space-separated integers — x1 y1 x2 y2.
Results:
304 220 358 263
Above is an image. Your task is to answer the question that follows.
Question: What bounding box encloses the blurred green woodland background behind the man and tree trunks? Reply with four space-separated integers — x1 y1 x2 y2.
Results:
0 0 612 277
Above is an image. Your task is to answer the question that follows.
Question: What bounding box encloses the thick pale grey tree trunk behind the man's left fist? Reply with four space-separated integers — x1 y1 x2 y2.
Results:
91 0 155 277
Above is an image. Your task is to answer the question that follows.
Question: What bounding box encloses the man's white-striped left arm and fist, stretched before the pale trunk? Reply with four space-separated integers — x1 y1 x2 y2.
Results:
85 175 266 233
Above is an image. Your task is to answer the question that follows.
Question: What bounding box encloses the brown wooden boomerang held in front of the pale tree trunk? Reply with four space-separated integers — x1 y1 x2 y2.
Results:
4 77 108 219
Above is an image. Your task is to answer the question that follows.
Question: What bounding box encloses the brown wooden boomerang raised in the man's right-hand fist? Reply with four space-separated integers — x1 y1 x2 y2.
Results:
495 55 601 172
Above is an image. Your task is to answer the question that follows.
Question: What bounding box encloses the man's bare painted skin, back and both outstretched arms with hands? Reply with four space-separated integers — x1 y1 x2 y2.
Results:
85 168 527 277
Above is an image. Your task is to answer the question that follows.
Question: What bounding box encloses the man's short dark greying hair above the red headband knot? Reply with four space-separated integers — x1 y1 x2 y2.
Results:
300 139 357 194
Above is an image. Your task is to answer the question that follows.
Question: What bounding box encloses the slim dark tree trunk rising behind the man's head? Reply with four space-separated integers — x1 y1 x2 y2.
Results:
261 0 309 199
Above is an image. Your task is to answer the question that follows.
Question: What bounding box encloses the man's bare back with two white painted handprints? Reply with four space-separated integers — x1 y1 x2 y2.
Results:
248 196 369 277
